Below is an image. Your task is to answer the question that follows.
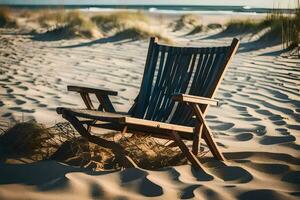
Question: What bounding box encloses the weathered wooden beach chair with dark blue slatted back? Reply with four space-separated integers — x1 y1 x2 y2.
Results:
57 38 239 168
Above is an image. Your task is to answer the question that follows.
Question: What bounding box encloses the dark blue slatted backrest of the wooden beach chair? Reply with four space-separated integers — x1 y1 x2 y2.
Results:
130 38 239 125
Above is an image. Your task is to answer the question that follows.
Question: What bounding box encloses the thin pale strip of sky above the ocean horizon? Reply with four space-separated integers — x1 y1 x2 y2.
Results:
0 0 299 8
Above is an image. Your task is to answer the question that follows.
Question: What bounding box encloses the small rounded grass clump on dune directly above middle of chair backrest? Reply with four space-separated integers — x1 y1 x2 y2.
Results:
171 15 202 32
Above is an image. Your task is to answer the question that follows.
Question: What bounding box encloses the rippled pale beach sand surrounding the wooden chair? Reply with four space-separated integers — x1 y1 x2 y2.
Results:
0 11 300 200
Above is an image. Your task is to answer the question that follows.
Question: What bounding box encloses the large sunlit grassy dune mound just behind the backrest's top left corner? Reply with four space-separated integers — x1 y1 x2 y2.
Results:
92 11 172 43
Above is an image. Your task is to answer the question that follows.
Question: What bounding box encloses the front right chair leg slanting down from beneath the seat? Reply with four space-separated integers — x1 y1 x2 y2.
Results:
170 131 204 171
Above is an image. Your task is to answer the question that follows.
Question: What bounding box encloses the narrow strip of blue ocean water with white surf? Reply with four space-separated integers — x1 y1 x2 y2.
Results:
6 5 288 15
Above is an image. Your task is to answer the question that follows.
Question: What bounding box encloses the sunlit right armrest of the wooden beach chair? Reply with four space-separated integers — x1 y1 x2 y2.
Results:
172 94 218 106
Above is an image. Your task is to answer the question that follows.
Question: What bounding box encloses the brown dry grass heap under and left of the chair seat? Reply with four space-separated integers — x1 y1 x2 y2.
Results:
0 122 186 170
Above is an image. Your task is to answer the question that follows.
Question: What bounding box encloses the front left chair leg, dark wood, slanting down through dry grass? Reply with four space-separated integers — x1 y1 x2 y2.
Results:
63 113 138 168
